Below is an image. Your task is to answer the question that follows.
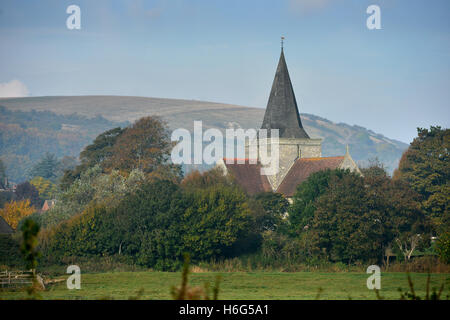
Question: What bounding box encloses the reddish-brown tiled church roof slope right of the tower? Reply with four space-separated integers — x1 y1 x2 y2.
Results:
277 156 344 197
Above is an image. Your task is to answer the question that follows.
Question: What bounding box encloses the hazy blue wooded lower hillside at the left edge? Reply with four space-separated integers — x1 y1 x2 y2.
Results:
0 105 128 183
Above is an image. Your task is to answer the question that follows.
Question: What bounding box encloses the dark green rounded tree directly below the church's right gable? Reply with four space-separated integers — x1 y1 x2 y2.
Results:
311 174 383 264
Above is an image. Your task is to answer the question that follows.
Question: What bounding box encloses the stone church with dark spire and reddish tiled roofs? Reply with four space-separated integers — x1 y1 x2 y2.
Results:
217 46 361 199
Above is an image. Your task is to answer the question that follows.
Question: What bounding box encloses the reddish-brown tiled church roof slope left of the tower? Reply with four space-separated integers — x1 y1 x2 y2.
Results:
224 159 272 195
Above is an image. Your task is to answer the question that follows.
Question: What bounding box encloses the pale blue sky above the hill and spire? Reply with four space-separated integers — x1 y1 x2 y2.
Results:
0 0 450 143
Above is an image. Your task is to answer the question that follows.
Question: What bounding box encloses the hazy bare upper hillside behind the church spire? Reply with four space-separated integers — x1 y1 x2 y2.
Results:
0 96 408 172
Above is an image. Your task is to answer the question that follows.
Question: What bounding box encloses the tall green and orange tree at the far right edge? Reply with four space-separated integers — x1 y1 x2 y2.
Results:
394 126 450 234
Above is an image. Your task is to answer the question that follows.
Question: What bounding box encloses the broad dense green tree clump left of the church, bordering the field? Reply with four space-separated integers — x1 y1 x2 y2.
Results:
43 180 255 270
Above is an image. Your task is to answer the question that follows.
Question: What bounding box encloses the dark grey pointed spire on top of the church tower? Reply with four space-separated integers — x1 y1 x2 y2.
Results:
261 49 309 138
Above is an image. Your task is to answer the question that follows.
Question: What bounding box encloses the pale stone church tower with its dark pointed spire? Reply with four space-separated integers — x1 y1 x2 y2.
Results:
261 47 322 190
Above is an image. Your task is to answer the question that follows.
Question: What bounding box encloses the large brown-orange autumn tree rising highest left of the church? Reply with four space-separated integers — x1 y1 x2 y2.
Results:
61 117 182 190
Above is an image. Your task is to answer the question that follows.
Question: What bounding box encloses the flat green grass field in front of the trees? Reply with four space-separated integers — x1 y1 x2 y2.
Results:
0 272 450 300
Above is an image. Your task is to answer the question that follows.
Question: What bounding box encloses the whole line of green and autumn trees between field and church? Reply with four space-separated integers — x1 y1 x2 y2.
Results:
1 117 449 270
